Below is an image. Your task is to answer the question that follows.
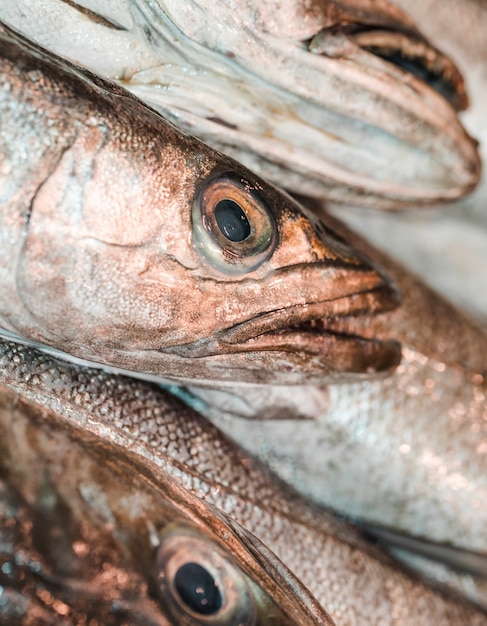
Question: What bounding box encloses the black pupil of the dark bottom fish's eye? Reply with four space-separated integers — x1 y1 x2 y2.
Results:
174 563 222 615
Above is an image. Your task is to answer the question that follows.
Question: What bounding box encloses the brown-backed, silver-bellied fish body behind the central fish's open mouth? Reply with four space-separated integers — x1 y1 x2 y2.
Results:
192 213 487 574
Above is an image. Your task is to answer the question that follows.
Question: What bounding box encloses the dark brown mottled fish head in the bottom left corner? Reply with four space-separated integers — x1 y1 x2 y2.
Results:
0 386 333 626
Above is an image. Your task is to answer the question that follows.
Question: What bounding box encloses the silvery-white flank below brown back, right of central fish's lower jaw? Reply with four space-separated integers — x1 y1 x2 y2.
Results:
198 348 487 552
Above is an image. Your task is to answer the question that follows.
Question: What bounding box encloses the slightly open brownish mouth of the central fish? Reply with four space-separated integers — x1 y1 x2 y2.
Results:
168 284 401 382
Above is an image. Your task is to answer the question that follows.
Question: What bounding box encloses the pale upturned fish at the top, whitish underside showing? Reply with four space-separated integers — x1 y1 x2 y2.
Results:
0 0 479 207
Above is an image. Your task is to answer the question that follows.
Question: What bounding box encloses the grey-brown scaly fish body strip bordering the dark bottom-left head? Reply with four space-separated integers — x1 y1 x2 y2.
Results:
0 343 487 626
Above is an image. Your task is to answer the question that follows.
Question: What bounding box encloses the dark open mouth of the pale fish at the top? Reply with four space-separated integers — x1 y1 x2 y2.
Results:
308 24 469 111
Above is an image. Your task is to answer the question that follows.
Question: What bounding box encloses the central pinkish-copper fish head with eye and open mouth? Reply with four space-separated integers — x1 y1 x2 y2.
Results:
0 24 400 383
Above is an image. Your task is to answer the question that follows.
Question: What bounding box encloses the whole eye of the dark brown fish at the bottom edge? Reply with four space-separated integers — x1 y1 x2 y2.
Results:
156 527 256 626
